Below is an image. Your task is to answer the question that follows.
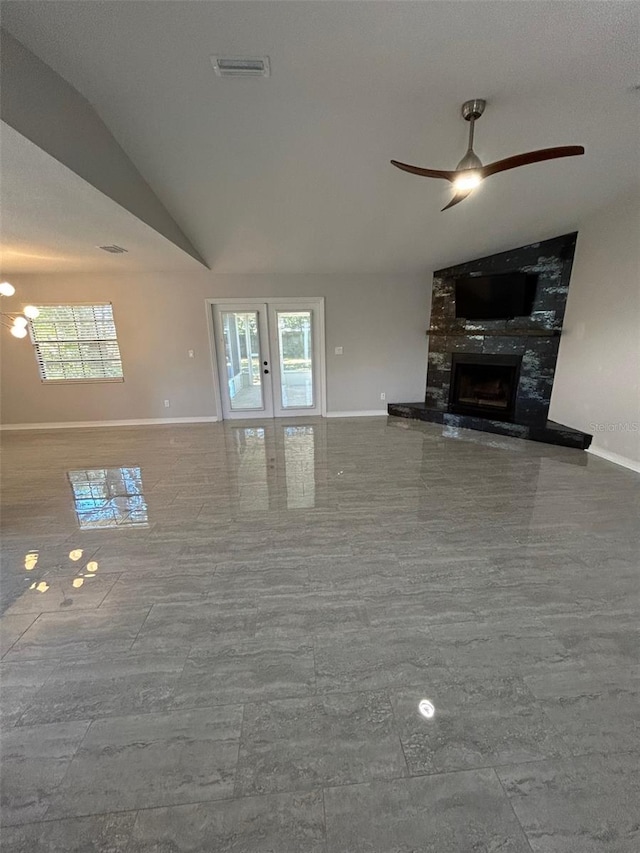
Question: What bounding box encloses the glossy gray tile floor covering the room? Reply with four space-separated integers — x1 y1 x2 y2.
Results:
0 418 640 853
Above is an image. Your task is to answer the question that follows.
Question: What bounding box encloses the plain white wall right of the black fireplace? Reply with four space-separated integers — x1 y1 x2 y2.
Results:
550 189 640 466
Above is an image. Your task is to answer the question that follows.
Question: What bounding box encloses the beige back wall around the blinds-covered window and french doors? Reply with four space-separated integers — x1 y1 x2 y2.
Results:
0 270 431 424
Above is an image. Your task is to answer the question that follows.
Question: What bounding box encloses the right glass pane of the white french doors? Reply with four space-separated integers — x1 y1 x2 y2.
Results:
277 311 314 409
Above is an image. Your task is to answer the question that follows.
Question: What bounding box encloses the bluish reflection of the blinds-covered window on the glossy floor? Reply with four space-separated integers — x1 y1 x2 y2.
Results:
69 468 149 530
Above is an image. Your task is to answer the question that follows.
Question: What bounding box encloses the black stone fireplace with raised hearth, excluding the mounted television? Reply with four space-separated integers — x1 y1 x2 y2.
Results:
388 233 591 449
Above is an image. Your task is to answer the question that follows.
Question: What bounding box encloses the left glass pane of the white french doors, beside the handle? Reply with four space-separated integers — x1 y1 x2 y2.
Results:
221 311 264 411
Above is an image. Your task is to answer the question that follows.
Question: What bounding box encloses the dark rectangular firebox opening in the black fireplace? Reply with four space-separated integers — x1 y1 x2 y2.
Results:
449 353 522 421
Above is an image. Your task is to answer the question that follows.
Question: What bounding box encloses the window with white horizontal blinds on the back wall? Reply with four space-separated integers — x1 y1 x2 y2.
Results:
30 302 123 382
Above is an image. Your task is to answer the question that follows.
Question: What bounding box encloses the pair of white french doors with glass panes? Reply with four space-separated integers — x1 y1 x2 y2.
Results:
211 299 324 420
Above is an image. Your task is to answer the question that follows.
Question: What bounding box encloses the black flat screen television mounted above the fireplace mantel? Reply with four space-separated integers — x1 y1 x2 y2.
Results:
455 272 538 320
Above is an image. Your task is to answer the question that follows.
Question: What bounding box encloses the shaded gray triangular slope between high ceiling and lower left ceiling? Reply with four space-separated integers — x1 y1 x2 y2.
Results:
0 30 206 266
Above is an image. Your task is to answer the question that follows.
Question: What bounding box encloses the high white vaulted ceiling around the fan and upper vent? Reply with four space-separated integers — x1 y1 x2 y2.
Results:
3 0 640 273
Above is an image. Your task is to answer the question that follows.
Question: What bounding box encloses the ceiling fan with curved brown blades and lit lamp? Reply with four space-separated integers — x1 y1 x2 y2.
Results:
391 98 584 210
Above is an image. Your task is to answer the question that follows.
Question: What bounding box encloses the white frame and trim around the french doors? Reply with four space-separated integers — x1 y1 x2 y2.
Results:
205 296 327 420
